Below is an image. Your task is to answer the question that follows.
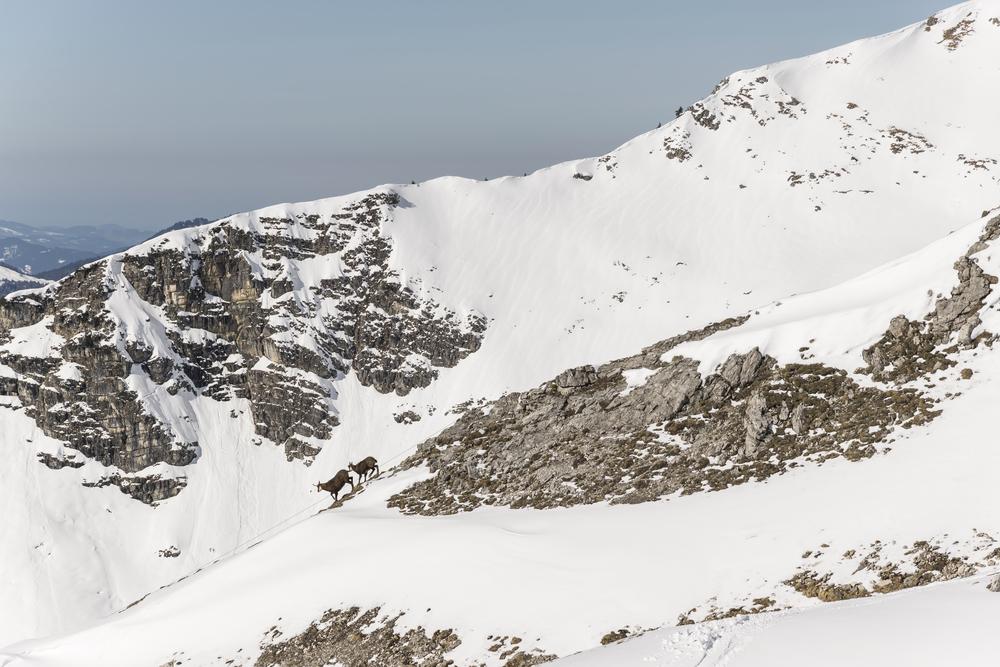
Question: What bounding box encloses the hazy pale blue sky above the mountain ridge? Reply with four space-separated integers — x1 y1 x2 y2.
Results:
0 0 947 228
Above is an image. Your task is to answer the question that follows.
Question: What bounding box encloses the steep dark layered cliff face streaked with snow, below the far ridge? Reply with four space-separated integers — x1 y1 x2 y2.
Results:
0 192 486 502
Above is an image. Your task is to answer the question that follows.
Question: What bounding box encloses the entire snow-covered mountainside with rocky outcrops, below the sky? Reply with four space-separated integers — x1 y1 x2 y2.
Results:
0 0 1000 665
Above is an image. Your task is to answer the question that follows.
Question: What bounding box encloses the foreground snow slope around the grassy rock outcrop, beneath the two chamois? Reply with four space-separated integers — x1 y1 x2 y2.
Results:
7 206 1000 665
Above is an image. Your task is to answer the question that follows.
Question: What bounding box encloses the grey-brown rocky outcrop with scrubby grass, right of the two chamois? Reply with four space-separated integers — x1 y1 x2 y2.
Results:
389 217 1000 514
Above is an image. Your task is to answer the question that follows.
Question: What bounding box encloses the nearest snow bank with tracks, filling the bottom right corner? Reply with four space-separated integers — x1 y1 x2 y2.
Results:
552 578 1000 667
